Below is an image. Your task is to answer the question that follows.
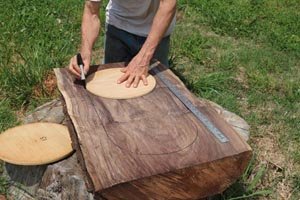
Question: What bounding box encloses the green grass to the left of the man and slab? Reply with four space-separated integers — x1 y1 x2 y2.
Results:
0 0 82 110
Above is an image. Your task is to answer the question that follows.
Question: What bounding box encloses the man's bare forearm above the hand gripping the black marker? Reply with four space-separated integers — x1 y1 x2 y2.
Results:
80 1 100 58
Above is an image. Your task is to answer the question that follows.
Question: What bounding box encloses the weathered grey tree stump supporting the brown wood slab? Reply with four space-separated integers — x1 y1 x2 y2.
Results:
4 73 249 200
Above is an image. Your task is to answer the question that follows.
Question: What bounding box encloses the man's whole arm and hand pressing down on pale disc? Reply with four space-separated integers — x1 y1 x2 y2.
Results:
118 0 176 87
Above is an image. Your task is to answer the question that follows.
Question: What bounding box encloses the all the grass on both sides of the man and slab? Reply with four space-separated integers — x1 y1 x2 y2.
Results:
0 0 300 200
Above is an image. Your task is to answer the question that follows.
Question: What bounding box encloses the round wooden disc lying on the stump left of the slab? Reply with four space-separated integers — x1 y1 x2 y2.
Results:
0 123 73 165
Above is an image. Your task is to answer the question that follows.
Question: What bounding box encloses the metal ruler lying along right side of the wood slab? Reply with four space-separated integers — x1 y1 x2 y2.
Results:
150 62 229 143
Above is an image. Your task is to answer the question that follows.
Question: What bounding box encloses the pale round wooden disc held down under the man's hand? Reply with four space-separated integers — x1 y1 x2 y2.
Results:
86 68 156 99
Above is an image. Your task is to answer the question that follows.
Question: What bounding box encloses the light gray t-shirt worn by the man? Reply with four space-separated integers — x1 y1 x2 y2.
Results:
89 0 175 37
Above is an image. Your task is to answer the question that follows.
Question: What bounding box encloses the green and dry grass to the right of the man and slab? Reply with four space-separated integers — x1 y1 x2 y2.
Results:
172 0 300 199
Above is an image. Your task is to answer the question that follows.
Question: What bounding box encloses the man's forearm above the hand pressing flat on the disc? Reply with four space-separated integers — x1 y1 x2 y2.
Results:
139 0 176 61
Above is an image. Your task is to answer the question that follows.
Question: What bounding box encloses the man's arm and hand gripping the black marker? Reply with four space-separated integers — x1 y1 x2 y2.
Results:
69 1 100 78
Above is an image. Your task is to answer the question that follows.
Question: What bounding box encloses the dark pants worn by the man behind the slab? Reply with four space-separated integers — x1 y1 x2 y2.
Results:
104 24 170 66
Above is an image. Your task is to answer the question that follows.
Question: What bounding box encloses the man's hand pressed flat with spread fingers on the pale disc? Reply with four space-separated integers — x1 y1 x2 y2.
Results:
118 54 150 88
